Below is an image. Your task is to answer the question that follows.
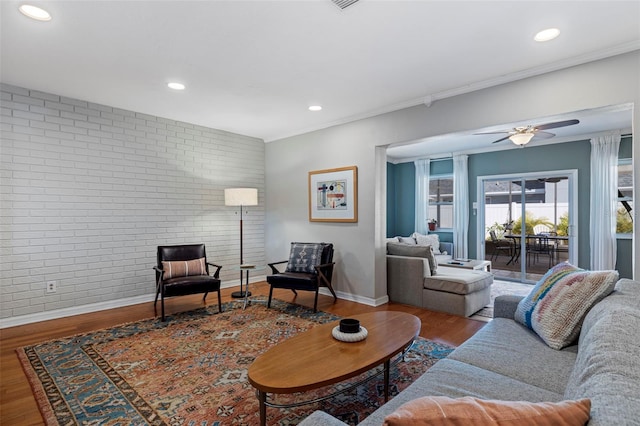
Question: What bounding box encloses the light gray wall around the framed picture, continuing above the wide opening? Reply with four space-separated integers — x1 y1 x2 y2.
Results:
265 51 640 304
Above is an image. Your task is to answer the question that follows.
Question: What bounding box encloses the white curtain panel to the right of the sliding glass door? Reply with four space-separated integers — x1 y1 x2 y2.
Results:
589 134 620 270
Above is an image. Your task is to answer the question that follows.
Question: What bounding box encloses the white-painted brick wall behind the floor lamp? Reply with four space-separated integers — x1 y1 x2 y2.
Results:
0 84 265 318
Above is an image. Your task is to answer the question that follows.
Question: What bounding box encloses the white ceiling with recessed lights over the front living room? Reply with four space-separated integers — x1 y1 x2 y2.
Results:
0 0 640 146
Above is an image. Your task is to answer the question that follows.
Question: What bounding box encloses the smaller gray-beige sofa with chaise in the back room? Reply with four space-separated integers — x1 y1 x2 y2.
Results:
387 242 493 317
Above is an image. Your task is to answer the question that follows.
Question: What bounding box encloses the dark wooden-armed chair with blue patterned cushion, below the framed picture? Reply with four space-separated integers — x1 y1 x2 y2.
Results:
267 242 338 312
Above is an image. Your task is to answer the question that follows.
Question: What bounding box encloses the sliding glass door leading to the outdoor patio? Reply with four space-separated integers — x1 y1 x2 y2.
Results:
478 171 577 282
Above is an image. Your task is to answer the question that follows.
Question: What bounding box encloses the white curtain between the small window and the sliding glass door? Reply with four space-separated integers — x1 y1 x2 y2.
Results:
453 155 469 259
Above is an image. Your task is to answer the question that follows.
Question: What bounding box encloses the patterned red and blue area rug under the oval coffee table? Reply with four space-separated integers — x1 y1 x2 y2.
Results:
18 300 453 426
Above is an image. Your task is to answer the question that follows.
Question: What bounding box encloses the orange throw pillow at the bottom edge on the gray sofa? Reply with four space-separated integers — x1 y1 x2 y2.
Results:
384 396 591 426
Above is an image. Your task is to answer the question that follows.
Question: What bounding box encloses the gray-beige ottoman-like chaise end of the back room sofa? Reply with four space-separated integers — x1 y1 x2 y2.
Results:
422 266 493 317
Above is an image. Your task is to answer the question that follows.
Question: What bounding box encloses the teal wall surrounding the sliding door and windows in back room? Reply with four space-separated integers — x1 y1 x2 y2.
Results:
387 137 633 272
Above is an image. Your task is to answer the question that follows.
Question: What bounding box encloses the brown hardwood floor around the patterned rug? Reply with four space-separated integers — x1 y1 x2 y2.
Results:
0 282 485 425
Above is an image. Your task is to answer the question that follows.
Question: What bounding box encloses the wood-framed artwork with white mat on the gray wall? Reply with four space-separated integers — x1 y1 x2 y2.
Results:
309 166 358 222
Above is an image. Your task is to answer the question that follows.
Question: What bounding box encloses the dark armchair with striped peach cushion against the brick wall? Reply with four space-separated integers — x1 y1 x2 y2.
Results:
153 244 222 321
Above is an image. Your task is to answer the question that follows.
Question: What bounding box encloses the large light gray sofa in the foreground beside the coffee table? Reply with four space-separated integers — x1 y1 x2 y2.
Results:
300 279 640 426
